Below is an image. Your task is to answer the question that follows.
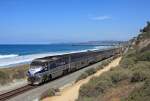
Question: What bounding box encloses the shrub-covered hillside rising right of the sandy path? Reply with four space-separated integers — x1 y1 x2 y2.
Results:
77 22 150 101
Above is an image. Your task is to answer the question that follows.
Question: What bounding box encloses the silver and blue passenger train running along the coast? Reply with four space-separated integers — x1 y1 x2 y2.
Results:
27 48 120 85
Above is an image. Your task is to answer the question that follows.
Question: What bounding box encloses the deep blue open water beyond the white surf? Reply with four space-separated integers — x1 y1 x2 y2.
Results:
0 44 99 55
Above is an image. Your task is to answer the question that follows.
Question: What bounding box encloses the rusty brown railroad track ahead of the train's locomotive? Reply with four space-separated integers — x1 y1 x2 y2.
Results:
0 85 35 101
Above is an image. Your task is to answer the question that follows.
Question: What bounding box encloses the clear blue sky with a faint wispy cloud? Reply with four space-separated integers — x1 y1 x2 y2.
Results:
0 0 150 44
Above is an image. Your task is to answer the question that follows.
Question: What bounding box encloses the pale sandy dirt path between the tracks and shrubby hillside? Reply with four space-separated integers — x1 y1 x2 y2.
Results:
43 57 121 101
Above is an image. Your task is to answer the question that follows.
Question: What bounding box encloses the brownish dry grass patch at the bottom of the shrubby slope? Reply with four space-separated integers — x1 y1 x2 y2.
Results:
98 80 143 101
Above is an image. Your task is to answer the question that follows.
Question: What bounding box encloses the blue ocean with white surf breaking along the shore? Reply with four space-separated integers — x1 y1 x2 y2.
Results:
0 44 111 68
